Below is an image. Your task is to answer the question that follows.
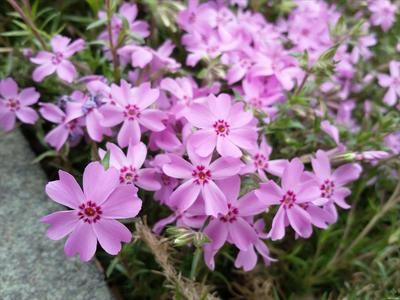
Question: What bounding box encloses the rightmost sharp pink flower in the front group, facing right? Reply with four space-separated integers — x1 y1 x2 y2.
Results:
311 150 362 223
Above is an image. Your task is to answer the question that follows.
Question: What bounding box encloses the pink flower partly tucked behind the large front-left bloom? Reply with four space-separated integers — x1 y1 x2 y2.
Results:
99 142 161 191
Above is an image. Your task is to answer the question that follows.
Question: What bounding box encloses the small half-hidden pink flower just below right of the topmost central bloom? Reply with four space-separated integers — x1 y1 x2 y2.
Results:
241 137 288 181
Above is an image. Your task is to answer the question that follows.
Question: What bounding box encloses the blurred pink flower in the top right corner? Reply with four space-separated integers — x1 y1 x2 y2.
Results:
368 0 397 32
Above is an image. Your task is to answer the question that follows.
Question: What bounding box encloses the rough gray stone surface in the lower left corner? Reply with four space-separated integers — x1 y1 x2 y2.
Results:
0 131 112 300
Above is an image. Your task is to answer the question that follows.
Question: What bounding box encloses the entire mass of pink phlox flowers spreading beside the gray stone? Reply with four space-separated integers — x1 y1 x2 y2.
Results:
0 0 400 271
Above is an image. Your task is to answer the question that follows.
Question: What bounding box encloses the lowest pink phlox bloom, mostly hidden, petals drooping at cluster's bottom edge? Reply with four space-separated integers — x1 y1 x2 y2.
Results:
235 219 276 272
